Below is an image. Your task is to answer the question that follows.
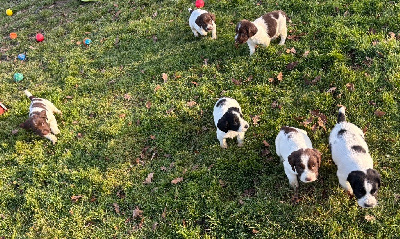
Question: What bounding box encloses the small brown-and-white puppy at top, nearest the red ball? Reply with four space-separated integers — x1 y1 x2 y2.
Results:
189 8 217 39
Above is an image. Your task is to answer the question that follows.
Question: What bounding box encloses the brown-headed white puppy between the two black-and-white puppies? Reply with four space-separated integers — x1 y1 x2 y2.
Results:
275 126 321 197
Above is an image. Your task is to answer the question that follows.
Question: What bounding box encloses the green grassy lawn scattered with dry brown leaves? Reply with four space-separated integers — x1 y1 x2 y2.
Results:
0 0 400 238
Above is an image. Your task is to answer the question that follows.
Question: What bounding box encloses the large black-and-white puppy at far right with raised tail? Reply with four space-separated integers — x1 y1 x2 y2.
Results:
329 106 381 208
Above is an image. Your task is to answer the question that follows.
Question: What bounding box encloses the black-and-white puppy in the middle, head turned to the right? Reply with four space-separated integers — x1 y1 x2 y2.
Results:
213 97 249 148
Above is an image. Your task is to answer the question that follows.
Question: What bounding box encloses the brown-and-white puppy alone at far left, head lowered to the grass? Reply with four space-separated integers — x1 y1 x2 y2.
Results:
20 90 61 144
